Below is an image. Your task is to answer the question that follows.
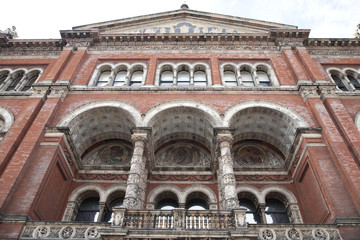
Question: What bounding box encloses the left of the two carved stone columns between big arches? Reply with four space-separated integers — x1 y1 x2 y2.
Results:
123 131 147 209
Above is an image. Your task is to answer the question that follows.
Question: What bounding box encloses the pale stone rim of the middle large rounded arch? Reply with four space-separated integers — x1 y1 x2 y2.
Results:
143 100 222 126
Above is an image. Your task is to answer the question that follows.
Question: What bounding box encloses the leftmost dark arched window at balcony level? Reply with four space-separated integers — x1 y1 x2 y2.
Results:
75 197 99 222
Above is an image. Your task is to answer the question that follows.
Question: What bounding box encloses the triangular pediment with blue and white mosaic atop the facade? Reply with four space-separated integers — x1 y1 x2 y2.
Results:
73 9 297 35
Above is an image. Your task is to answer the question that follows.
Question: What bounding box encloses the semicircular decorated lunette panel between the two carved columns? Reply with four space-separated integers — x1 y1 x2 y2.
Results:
155 142 210 169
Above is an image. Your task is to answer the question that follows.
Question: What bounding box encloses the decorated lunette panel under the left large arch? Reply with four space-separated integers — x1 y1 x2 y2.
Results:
81 140 133 169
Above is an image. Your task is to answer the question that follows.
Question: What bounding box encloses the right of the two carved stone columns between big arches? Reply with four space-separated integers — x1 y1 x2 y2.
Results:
216 130 239 210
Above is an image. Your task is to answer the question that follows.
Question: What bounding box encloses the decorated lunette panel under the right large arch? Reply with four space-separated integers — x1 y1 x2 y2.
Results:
232 142 285 169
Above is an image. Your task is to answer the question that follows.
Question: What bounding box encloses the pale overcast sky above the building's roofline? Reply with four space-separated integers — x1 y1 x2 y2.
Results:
0 0 360 39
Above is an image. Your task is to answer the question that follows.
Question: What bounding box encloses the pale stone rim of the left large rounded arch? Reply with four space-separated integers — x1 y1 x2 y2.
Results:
57 100 141 126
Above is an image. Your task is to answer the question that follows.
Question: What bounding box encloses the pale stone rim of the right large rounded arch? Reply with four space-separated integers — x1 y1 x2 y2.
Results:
223 100 310 127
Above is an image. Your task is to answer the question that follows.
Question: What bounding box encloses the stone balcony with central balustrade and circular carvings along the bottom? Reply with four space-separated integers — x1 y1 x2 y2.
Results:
20 208 342 240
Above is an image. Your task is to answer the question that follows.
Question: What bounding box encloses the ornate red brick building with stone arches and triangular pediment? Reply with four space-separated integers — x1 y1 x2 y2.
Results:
0 4 360 240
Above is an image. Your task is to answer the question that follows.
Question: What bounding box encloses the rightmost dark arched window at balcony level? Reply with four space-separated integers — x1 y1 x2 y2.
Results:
265 198 290 224
